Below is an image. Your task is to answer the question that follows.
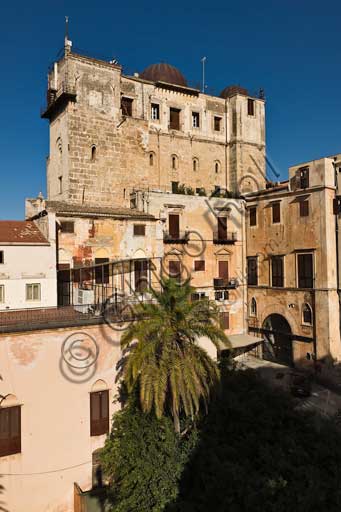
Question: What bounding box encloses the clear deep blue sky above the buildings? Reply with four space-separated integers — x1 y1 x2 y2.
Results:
0 0 341 219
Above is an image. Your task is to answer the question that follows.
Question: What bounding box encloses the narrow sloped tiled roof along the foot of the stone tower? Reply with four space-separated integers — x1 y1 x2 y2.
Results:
45 201 155 220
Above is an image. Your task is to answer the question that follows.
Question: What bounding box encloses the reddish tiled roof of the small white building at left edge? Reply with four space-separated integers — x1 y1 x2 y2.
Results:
0 220 49 245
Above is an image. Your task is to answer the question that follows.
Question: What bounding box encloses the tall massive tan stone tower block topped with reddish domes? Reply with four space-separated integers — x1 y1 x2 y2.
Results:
42 40 265 206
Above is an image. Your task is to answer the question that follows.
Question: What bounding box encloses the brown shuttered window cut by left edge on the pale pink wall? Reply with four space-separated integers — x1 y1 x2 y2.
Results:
0 406 21 457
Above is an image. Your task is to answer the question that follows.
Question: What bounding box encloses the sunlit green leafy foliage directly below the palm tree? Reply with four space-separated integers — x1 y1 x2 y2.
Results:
102 399 196 512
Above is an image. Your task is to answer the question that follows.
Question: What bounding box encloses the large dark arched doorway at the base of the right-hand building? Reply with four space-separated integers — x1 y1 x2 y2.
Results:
262 313 293 366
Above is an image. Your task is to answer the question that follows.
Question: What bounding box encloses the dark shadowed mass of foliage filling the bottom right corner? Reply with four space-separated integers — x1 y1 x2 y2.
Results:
167 360 341 512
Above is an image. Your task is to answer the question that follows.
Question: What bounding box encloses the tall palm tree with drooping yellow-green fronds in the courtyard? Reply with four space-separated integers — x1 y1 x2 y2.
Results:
121 279 228 432
